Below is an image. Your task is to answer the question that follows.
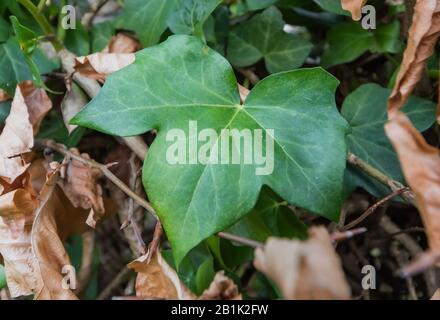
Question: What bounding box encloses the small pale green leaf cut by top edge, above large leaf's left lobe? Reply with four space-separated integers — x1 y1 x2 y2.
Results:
168 0 221 39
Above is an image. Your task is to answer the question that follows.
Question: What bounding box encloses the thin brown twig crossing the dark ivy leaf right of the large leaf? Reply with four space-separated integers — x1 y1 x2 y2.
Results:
347 152 416 206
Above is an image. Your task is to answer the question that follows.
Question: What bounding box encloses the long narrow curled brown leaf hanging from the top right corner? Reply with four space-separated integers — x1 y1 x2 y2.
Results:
388 0 440 119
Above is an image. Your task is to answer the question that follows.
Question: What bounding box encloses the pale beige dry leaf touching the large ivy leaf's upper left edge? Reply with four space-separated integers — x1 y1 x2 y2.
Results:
75 52 135 81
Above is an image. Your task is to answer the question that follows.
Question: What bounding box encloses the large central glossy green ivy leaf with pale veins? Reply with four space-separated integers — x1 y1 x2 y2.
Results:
72 36 347 264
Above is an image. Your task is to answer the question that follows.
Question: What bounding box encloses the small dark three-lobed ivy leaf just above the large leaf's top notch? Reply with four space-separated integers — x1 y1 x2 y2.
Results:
227 7 312 73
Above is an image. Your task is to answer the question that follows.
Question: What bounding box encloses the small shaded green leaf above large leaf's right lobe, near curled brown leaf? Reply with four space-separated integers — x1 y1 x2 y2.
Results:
322 20 400 67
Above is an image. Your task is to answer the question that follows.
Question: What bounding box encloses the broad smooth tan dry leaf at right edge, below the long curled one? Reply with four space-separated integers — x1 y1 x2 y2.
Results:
385 112 440 251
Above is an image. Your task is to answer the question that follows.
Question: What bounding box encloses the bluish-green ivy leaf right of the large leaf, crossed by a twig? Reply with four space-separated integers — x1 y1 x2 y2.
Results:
341 83 436 197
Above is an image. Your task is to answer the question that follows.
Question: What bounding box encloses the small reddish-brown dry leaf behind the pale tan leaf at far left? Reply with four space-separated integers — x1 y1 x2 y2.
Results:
19 81 52 135
